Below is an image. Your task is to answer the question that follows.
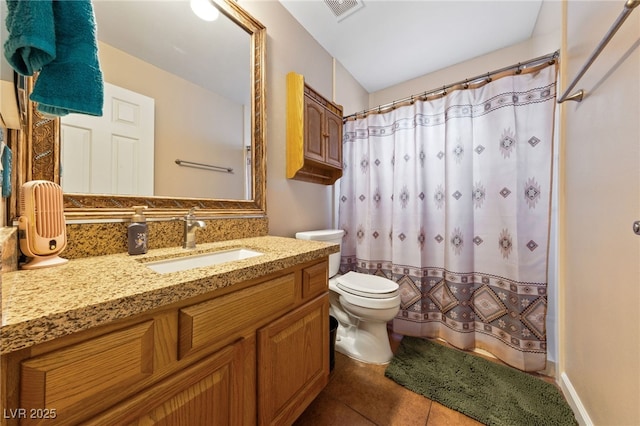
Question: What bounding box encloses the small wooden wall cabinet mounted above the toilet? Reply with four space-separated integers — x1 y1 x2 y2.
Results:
287 72 342 185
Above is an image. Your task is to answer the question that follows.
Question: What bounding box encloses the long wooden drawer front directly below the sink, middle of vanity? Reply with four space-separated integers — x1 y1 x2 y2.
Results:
178 274 296 358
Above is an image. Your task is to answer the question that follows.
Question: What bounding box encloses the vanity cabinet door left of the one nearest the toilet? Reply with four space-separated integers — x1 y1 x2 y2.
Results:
89 340 245 426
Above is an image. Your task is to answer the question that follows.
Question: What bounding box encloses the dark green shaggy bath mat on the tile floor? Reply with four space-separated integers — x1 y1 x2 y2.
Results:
385 336 578 426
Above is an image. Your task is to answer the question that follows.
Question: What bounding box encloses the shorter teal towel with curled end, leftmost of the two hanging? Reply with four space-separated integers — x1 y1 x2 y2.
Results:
4 1 56 75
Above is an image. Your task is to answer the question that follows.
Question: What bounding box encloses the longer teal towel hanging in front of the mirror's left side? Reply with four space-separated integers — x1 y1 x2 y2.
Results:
5 0 104 116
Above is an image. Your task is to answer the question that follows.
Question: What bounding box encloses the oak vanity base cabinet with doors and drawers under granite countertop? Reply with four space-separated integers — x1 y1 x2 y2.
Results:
0 257 329 426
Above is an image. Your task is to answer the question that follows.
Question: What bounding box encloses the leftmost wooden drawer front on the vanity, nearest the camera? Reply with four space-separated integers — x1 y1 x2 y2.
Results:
20 320 154 423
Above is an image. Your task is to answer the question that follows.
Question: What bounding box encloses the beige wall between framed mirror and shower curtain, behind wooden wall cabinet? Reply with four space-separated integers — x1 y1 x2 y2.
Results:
241 1 366 237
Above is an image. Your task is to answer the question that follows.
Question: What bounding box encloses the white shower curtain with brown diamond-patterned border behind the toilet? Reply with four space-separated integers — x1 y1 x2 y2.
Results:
339 62 556 371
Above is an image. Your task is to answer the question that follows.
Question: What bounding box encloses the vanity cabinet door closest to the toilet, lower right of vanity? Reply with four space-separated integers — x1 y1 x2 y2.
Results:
258 293 329 425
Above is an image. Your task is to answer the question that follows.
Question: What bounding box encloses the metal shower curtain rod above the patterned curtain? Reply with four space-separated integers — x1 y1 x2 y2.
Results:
343 52 556 121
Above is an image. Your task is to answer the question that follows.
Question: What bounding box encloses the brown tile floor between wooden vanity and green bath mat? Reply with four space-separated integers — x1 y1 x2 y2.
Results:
294 334 553 426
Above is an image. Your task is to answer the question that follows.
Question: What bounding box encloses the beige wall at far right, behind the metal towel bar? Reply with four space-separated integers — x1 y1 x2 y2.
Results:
560 1 640 425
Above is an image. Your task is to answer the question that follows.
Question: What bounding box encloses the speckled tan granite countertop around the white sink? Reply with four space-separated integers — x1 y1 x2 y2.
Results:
0 236 339 354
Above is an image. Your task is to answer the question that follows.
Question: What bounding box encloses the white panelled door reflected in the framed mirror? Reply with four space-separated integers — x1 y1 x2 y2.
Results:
60 83 155 196
